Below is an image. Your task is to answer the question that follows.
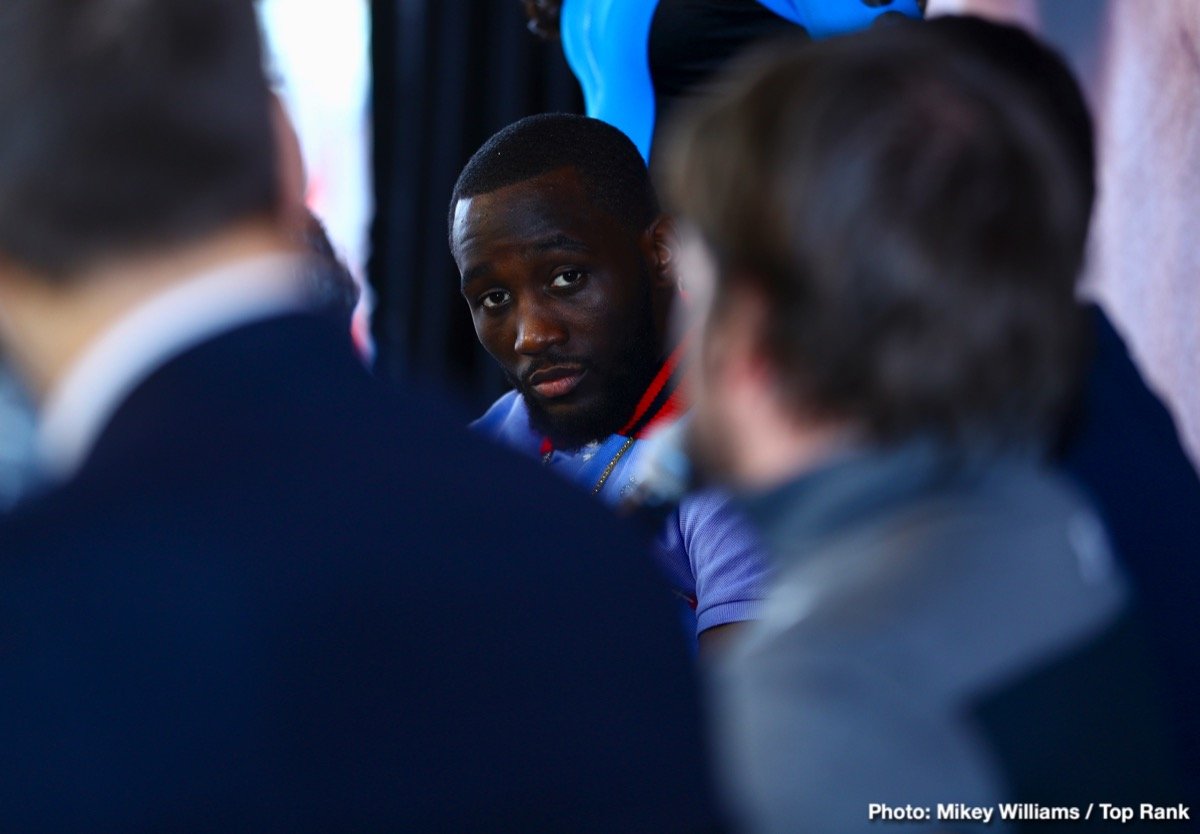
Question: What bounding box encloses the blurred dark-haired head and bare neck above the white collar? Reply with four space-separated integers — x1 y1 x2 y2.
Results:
0 0 296 400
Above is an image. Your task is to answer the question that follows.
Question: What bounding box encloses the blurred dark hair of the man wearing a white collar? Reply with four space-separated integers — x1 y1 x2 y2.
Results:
0 0 277 277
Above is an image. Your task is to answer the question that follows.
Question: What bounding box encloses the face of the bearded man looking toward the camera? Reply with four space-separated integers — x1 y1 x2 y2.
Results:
451 168 664 449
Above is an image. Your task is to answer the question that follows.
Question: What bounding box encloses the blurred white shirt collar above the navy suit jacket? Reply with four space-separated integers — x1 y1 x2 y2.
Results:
37 253 304 480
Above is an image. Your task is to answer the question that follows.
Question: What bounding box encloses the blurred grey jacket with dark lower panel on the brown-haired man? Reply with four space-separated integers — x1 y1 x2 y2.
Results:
713 442 1183 834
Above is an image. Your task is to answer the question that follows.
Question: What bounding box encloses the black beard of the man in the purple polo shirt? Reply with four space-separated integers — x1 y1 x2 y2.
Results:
506 282 662 451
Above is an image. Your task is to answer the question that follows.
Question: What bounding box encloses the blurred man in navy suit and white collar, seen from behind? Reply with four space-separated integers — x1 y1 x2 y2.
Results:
0 0 710 834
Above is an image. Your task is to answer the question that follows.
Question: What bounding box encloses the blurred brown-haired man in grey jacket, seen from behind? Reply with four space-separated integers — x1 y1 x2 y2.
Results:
667 19 1183 833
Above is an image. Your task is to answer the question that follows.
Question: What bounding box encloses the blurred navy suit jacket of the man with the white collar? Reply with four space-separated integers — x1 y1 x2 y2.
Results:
0 316 712 833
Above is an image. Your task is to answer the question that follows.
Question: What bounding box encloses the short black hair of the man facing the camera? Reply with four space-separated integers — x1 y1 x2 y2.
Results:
449 113 659 242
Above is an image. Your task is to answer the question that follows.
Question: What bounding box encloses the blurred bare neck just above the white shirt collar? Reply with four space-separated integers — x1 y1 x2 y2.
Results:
0 214 289 400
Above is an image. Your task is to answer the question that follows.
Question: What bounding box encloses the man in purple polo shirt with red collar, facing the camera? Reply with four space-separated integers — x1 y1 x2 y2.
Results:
449 114 763 643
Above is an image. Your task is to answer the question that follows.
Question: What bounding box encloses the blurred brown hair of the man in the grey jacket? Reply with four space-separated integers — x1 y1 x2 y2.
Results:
666 23 1092 445
